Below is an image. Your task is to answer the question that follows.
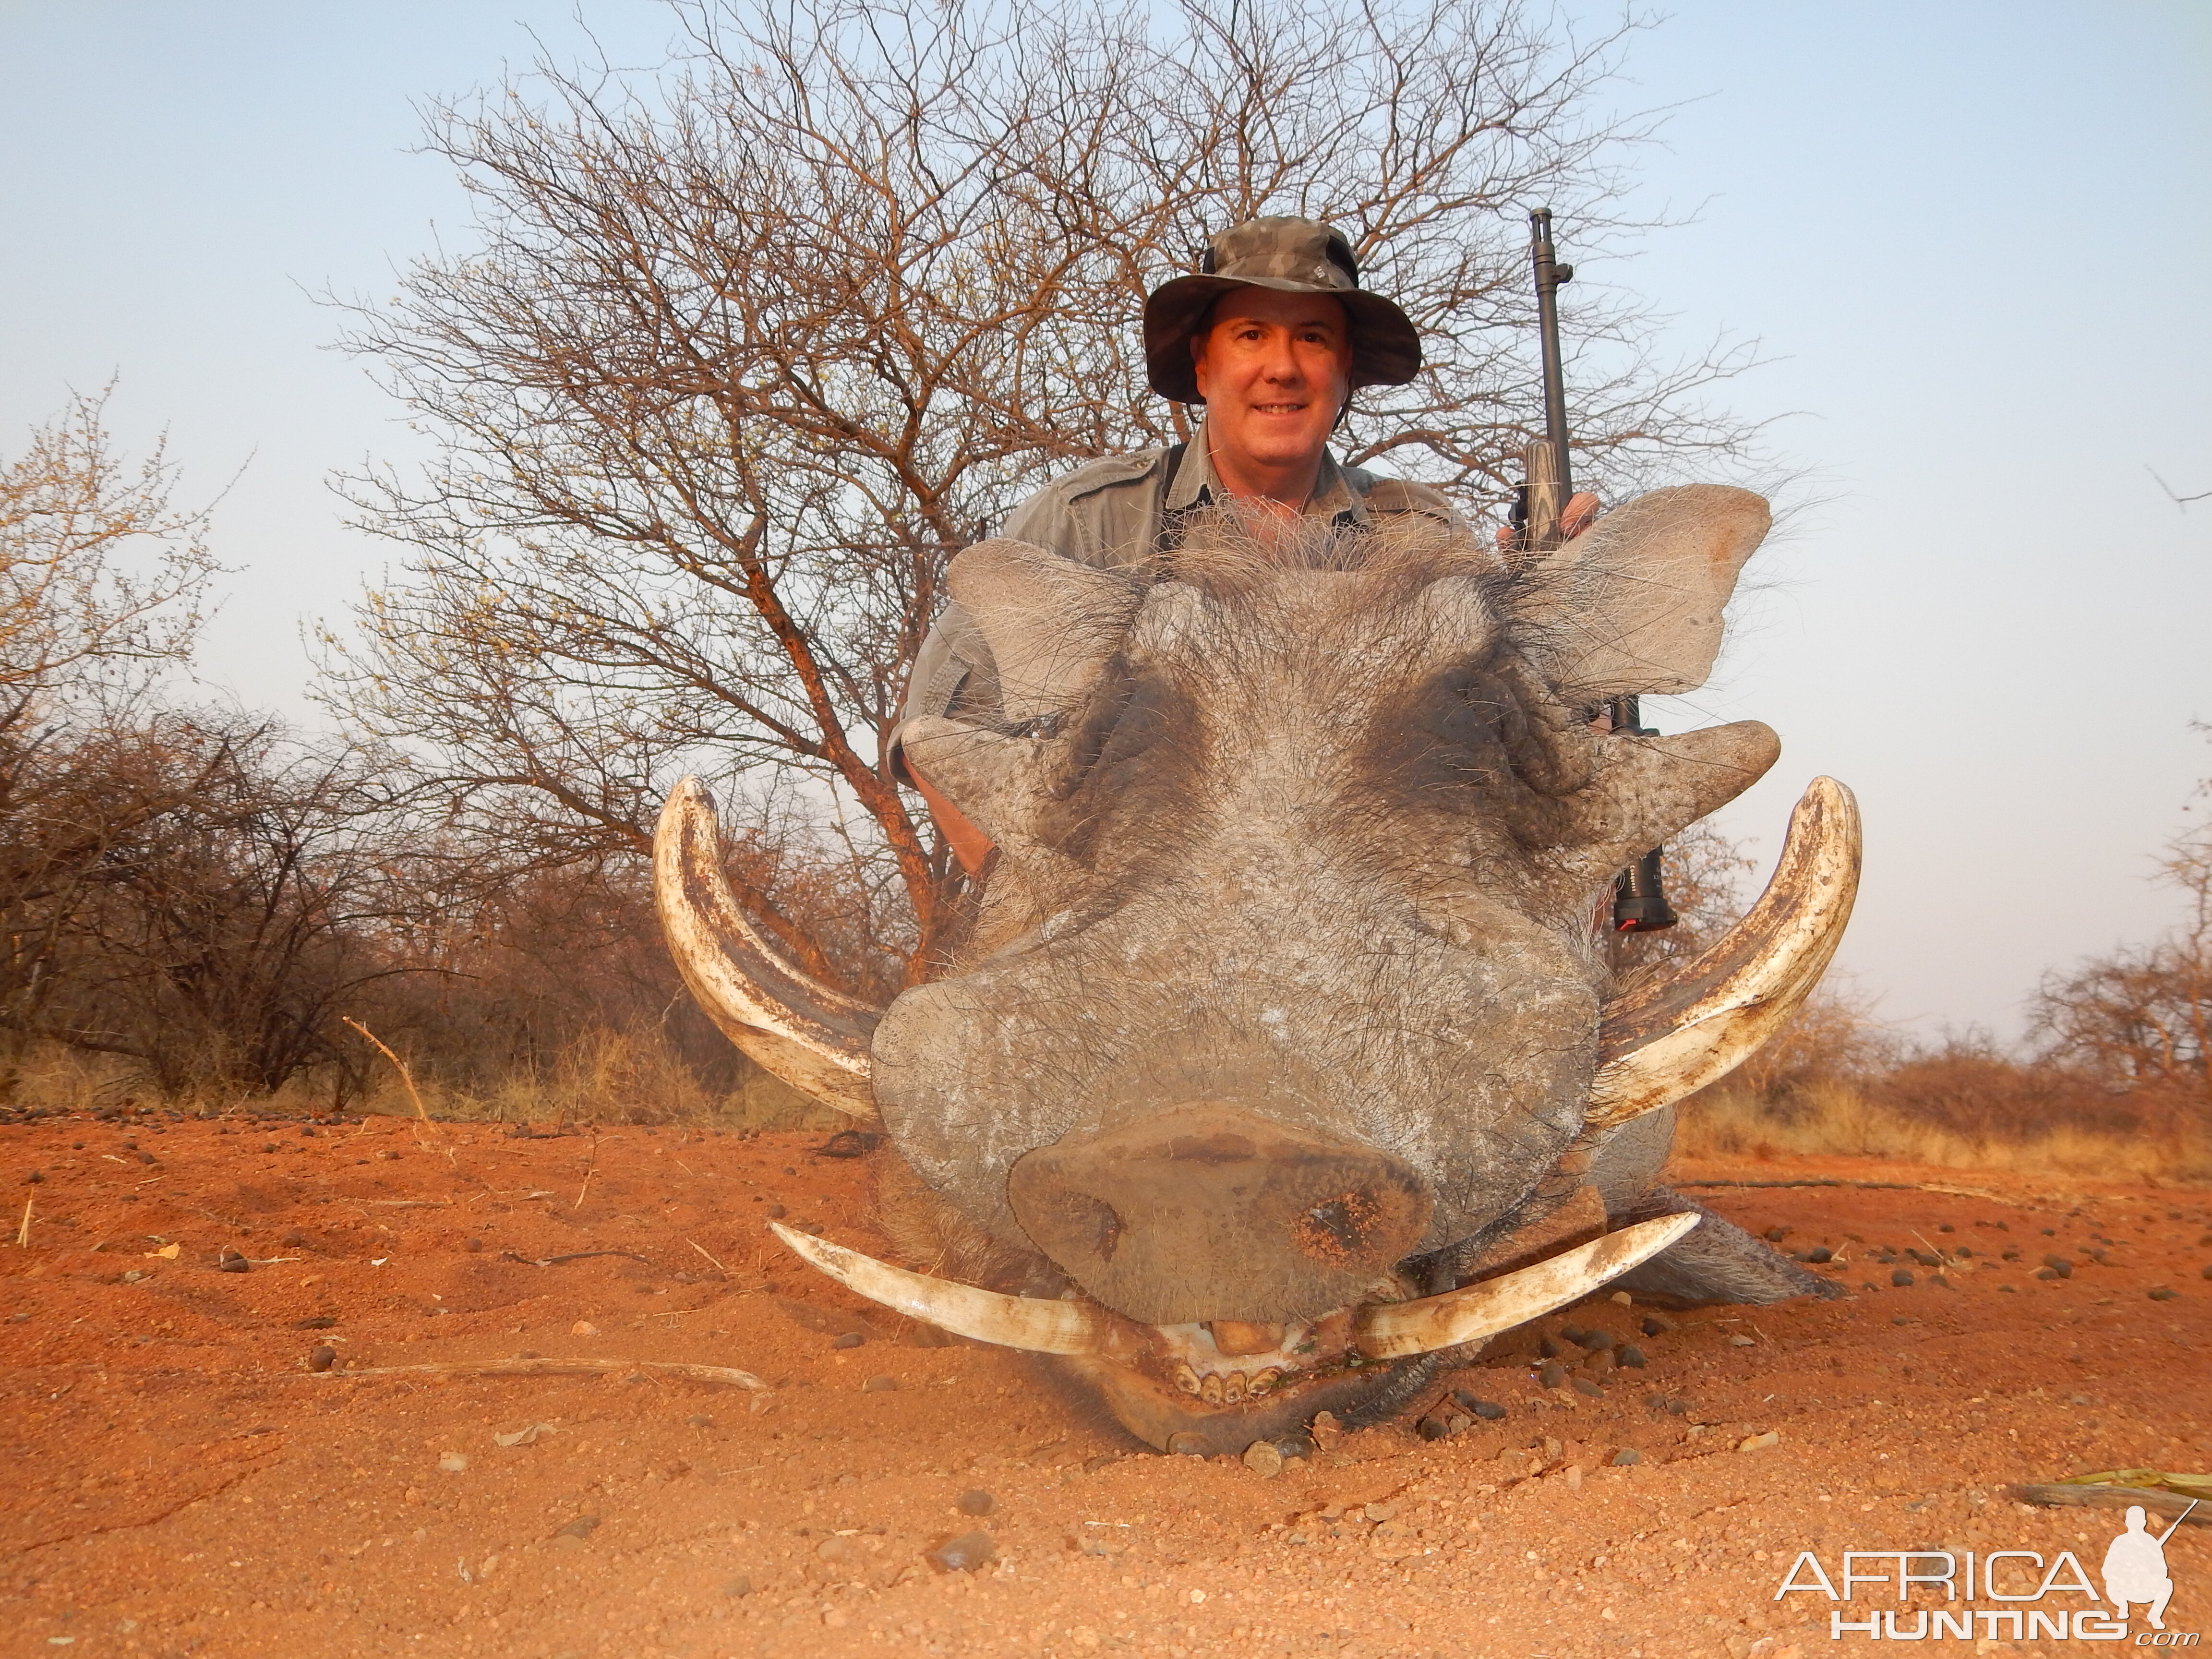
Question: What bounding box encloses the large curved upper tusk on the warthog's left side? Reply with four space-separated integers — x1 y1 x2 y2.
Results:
652 779 883 1121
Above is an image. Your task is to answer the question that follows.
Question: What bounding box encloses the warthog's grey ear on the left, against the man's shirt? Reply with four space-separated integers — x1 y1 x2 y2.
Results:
945 540 1139 723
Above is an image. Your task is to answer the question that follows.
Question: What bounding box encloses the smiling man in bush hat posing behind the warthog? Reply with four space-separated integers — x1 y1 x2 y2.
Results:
891 217 1597 874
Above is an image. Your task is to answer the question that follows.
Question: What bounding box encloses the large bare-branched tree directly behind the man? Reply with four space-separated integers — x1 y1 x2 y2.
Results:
325 0 1745 982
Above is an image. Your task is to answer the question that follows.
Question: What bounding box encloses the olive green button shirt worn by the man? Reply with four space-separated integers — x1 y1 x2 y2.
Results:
891 422 1464 765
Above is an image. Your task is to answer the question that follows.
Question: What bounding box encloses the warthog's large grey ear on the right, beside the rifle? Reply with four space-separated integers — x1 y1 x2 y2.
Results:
1513 484 1772 699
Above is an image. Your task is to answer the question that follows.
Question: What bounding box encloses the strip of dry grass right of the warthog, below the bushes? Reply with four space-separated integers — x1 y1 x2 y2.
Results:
1674 1069 2212 1186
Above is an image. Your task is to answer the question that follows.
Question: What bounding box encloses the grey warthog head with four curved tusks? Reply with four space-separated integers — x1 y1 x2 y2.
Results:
659 487 1856 1451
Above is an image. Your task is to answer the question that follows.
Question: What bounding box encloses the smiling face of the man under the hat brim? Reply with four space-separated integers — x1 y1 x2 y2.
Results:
1190 288 1351 484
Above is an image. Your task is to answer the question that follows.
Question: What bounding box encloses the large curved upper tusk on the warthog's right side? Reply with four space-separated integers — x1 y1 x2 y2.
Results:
1584 779 1860 1128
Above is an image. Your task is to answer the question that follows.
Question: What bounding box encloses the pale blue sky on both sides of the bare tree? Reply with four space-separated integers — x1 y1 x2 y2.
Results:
0 0 2212 1037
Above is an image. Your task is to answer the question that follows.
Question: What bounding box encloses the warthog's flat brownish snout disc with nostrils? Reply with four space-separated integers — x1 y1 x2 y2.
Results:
1007 1102 1431 1325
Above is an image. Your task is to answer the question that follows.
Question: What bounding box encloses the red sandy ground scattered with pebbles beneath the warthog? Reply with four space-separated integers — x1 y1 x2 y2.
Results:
0 1117 2212 1659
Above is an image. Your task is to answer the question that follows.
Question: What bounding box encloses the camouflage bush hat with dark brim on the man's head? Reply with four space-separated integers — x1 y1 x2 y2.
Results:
1143 217 1420 403
